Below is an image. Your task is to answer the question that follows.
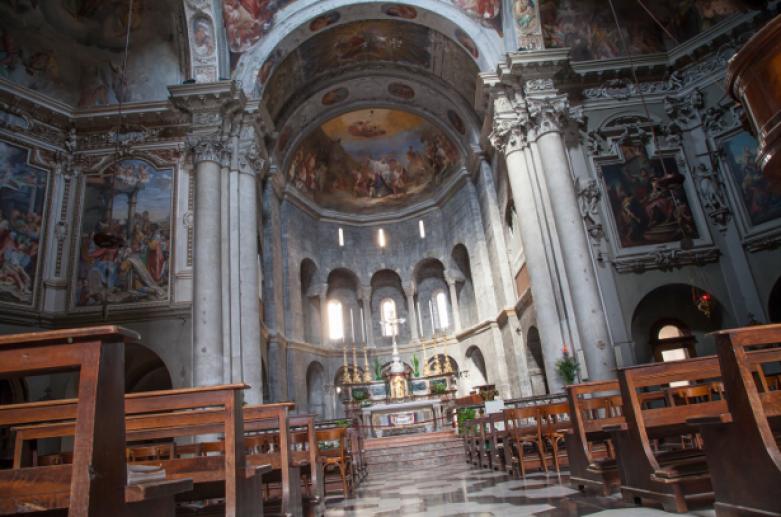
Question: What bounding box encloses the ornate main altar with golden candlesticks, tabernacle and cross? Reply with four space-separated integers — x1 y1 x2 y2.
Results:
342 319 457 438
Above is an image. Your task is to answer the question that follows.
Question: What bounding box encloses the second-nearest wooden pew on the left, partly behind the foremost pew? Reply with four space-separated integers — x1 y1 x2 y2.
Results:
3 384 269 516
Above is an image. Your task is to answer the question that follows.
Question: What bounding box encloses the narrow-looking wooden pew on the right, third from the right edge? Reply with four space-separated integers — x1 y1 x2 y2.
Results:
565 380 625 495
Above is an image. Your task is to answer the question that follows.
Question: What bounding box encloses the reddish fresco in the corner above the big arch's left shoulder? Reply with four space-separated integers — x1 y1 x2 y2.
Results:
222 0 292 53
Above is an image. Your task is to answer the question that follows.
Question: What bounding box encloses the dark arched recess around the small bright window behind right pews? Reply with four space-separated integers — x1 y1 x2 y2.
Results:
631 283 735 363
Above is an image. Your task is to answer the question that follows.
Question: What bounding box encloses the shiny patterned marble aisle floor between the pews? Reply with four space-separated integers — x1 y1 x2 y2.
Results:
325 464 715 517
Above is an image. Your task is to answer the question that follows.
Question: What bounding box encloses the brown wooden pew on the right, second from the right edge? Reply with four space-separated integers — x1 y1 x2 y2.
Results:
605 356 726 512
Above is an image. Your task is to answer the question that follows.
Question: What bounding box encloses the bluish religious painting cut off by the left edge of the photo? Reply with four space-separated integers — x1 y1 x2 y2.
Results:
0 142 47 305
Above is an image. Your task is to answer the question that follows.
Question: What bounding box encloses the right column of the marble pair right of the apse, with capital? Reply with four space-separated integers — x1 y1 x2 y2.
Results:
528 95 616 379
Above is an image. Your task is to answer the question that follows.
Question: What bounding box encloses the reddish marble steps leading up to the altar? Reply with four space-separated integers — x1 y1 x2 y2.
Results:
365 431 466 474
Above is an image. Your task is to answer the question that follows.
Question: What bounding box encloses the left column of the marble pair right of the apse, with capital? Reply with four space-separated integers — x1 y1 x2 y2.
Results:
490 91 564 393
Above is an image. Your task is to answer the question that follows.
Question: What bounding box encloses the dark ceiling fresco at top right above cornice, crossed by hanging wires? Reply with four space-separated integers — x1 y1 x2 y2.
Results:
540 0 743 61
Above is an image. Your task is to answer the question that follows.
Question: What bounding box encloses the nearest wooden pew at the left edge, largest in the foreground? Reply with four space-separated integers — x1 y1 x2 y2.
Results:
0 326 192 517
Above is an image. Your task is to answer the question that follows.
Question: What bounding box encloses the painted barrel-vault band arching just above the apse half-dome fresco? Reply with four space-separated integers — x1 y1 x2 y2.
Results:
258 20 478 125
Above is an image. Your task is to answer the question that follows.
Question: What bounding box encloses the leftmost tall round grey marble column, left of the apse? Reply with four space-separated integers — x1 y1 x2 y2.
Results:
192 136 225 386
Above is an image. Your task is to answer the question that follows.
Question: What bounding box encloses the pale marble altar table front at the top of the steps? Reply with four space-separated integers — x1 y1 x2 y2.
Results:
361 399 442 438
